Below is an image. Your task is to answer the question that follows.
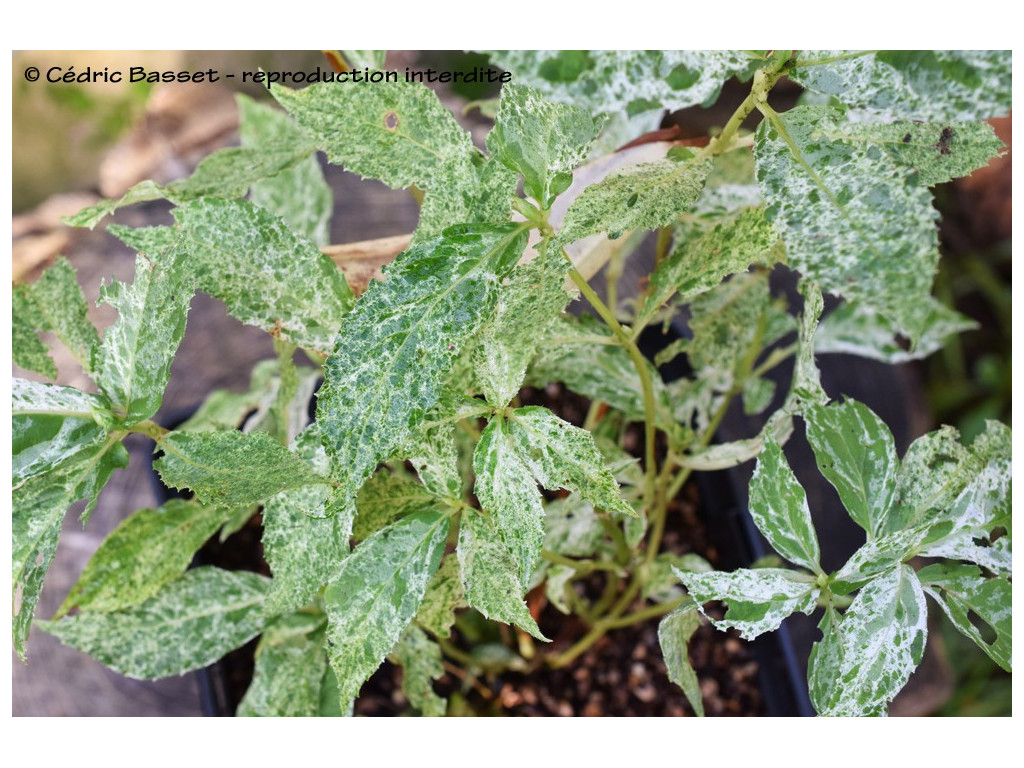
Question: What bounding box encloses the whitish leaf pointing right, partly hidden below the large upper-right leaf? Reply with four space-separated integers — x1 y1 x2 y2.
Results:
814 296 978 362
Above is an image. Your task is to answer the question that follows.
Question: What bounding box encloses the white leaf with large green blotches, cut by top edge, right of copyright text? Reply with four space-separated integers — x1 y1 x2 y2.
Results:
489 50 759 115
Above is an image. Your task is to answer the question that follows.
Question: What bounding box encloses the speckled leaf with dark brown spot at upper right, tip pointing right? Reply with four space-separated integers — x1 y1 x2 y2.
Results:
823 120 1002 186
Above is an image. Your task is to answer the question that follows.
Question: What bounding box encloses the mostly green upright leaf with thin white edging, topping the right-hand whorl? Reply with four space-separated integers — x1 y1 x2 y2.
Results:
804 399 899 538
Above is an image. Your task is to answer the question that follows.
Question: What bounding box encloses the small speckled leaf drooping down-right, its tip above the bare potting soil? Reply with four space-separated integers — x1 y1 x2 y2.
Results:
458 512 547 640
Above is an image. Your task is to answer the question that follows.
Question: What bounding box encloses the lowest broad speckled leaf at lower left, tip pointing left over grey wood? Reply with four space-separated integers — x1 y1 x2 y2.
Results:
37 566 269 680
